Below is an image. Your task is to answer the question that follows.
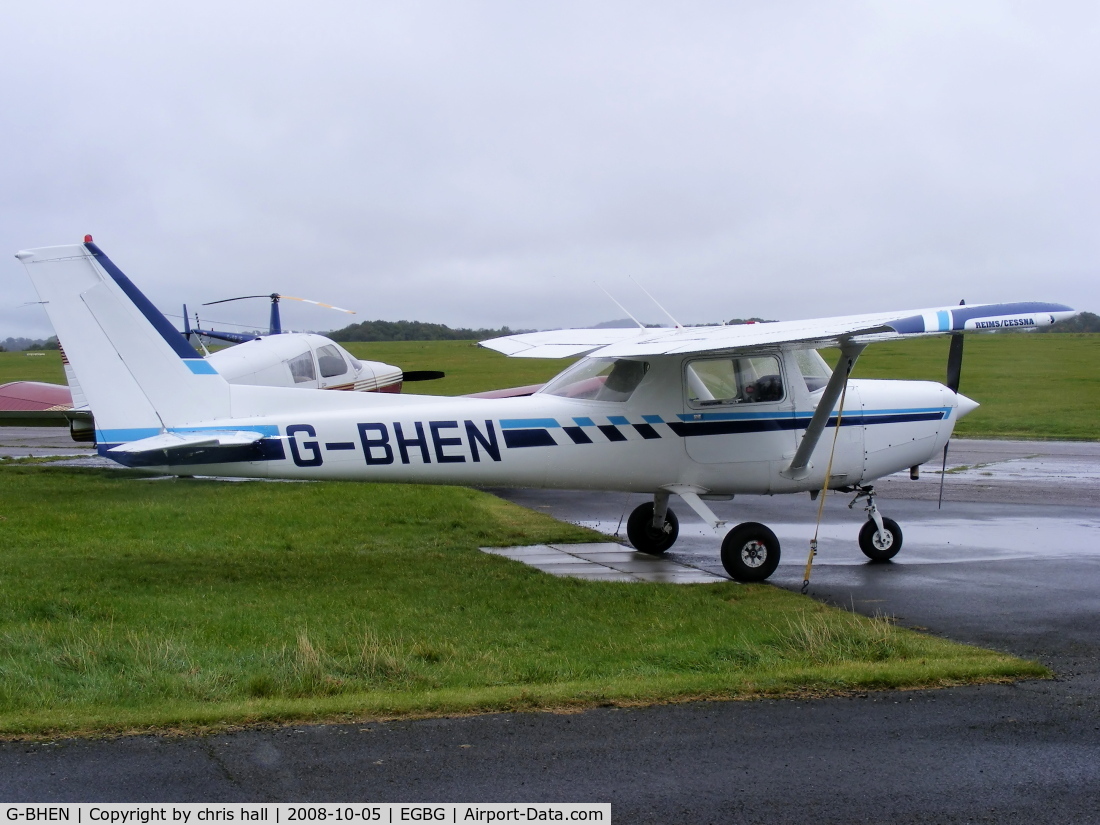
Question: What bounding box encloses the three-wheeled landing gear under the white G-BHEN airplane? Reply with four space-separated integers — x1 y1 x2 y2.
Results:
626 486 902 582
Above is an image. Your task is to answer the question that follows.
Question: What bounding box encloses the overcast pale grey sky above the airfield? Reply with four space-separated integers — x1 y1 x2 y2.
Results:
0 0 1100 340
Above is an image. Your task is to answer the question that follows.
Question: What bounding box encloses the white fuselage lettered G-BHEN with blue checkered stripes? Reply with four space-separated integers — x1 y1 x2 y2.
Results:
99 351 958 495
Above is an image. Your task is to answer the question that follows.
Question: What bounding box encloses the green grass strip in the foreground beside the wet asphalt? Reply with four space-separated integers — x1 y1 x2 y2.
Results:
0 465 1046 736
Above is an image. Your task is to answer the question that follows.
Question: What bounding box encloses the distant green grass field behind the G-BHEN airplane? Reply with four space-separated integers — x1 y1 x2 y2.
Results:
0 333 1100 441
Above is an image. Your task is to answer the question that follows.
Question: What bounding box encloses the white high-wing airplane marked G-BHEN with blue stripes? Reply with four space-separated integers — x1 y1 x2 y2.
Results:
15 242 1076 581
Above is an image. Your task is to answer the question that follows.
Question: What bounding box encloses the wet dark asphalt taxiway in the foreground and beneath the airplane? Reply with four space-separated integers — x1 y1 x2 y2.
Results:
0 441 1100 824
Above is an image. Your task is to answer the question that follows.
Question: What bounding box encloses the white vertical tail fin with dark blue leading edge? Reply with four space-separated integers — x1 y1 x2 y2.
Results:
15 237 231 446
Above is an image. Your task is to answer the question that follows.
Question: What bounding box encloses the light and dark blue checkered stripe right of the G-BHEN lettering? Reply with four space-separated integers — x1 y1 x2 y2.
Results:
501 407 952 448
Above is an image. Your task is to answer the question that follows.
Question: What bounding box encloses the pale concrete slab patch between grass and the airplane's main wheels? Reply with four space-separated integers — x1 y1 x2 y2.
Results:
481 541 729 584
